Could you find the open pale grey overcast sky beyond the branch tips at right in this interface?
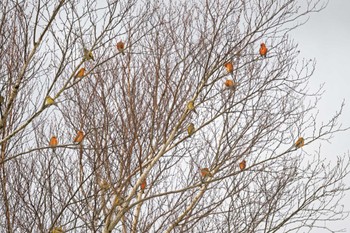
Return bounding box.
[292,0,350,232]
